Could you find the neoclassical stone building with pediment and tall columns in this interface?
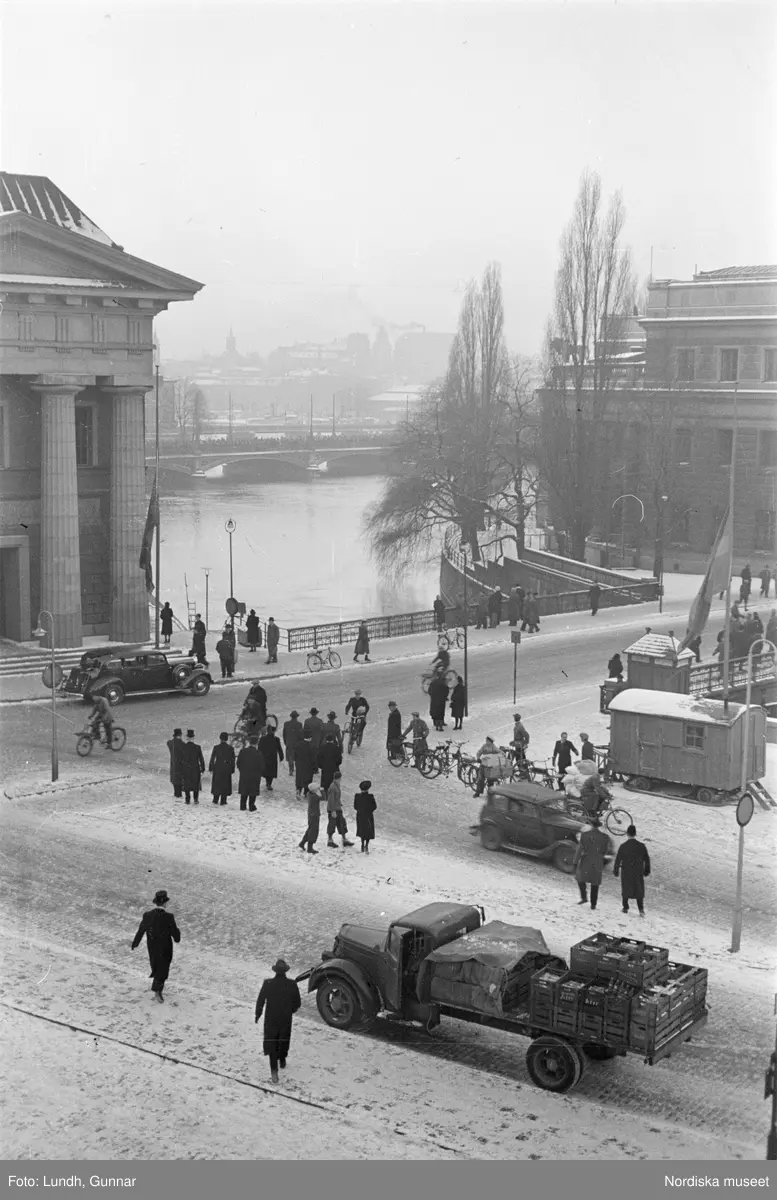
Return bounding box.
[0,173,201,647]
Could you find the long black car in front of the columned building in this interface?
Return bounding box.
[62,646,212,704]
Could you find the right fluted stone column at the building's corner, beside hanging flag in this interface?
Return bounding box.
[101,386,150,642]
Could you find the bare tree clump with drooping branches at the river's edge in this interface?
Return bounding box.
[365,264,536,572]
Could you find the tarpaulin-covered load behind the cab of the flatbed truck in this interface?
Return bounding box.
[416,920,566,1015]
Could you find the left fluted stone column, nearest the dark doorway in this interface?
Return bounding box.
[31,382,84,646]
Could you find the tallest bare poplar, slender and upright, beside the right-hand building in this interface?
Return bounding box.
[538,170,636,559]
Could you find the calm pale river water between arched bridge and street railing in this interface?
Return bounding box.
[159,476,440,629]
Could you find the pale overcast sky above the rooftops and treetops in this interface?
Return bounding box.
[1,0,777,358]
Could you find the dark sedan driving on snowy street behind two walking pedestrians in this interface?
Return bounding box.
[470,782,615,875]
